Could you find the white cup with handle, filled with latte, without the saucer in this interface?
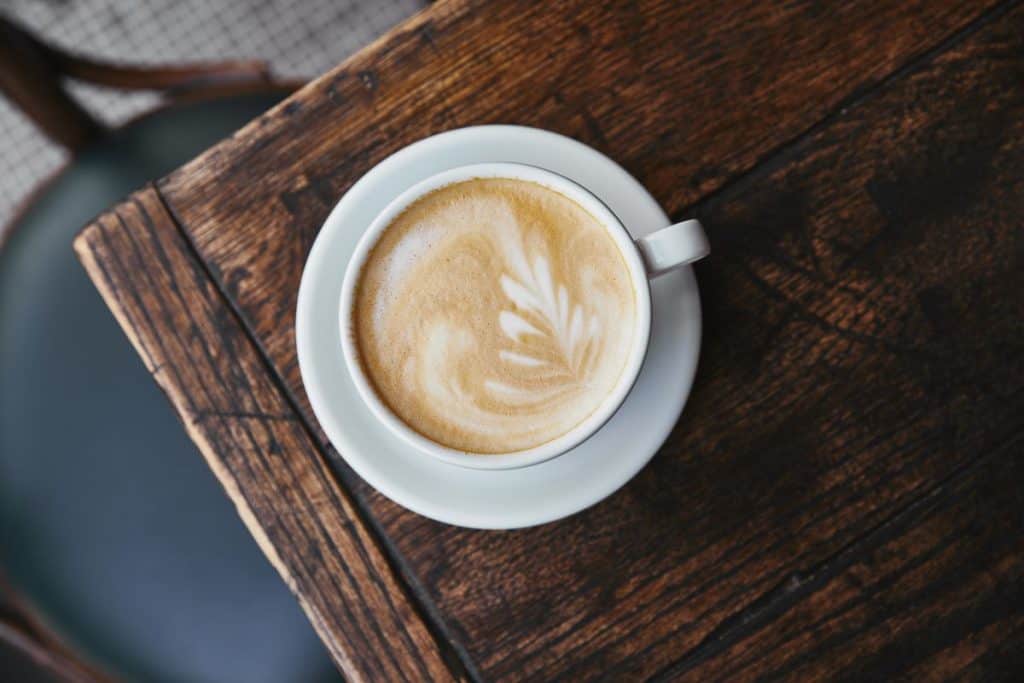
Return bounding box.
[339,163,709,469]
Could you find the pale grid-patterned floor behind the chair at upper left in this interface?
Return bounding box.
[0,0,424,229]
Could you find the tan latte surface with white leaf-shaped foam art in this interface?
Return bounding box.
[350,178,636,454]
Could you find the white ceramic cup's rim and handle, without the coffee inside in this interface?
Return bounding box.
[339,163,710,470]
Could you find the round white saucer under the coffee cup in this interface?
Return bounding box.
[296,126,700,528]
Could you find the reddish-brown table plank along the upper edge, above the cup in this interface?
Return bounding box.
[160,0,995,390]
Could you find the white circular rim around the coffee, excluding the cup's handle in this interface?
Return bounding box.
[338,162,651,470]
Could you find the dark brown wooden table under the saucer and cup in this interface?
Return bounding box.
[75,0,1024,681]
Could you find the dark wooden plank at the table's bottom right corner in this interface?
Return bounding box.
[659,448,1024,683]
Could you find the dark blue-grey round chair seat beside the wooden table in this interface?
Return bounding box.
[0,94,340,683]
